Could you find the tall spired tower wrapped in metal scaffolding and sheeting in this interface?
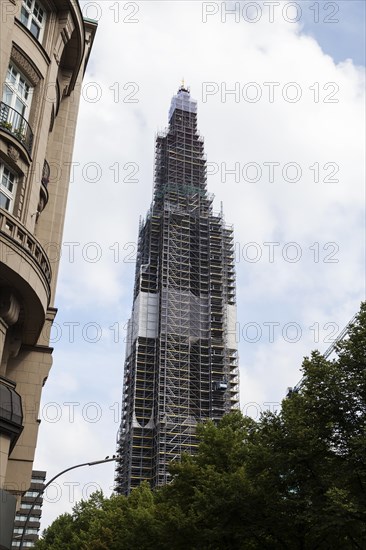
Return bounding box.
[116,88,239,494]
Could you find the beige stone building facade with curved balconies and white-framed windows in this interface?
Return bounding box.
[0,0,96,520]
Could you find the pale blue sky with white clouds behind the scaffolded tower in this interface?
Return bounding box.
[34,0,365,528]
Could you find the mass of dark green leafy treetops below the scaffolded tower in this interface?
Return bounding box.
[36,304,366,550]
